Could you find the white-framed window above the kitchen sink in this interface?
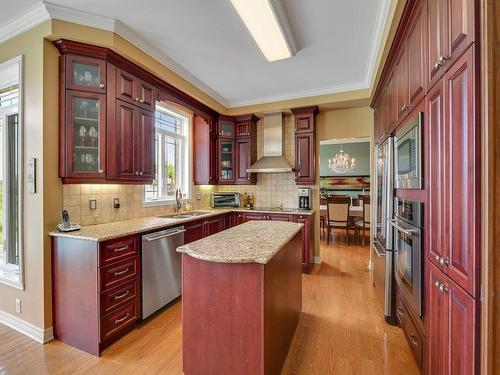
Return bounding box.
[144,104,191,204]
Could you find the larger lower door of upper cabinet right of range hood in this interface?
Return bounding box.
[295,133,316,184]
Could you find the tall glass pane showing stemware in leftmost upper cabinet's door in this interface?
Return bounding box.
[73,98,100,173]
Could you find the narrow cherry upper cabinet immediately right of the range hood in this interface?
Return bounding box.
[291,106,319,185]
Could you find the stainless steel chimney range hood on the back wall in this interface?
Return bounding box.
[247,112,293,173]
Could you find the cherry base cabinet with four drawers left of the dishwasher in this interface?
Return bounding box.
[52,236,141,356]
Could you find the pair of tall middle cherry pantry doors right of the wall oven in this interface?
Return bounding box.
[428,46,481,297]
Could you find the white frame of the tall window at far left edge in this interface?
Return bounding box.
[0,55,25,290]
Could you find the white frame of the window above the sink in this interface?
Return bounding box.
[142,102,193,207]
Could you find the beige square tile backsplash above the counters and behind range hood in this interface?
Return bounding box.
[63,116,317,225]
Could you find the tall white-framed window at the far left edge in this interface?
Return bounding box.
[0,56,23,288]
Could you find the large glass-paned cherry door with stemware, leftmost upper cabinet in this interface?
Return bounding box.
[61,90,106,179]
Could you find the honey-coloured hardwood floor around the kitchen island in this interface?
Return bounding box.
[0,237,418,375]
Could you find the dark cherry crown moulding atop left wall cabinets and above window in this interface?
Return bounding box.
[54,39,219,119]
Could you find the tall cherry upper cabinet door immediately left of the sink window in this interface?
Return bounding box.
[134,109,155,181]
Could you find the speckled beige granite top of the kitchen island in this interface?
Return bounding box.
[177,221,303,264]
